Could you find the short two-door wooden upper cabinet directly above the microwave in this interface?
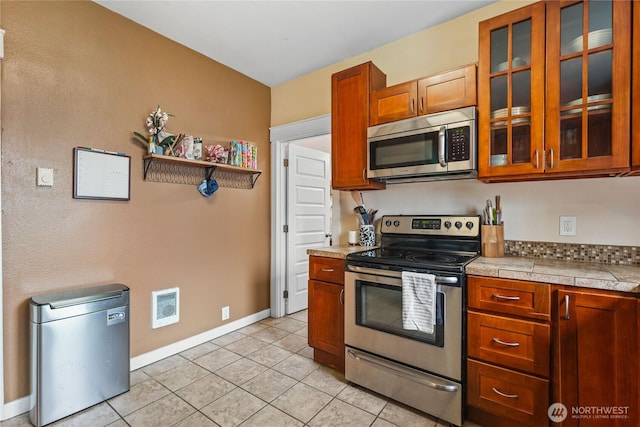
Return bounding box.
[370,64,477,126]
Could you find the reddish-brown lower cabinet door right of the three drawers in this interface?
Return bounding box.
[553,287,640,427]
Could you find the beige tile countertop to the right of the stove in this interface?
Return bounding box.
[466,257,640,296]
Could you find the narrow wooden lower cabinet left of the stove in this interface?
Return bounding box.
[308,256,344,372]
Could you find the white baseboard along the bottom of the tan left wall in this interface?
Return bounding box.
[0,309,271,421]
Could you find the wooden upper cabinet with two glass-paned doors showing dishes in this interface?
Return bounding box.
[478,0,631,181]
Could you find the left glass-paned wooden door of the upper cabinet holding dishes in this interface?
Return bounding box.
[478,2,545,179]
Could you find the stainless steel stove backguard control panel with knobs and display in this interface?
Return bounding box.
[380,215,480,237]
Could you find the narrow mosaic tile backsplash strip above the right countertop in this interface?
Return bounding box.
[504,240,640,265]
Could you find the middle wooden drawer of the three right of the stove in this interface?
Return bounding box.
[467,311,551,377]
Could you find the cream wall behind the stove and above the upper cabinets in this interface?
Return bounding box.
[271,0,640,246]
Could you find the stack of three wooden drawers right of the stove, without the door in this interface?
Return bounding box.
[466,276,551,427]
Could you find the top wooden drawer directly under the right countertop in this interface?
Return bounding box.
[467,276,551,321]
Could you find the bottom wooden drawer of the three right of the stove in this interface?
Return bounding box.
[467,360,549,426]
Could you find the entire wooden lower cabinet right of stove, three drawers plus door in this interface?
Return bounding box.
[466,276,640,427]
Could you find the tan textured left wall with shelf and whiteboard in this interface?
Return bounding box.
[0,1,271,402]
